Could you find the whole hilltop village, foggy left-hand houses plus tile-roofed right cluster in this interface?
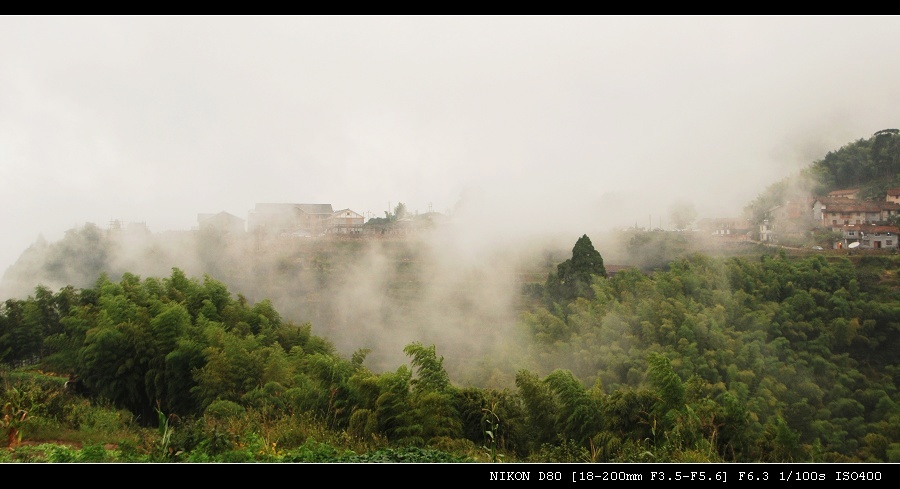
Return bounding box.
[190,187,900,250]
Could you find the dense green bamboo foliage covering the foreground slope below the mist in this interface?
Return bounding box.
[0,242,900,462]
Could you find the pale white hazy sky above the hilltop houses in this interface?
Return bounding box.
[0,16,900,273]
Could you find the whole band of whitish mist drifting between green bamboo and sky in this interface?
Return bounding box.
[0,124,900,385]
